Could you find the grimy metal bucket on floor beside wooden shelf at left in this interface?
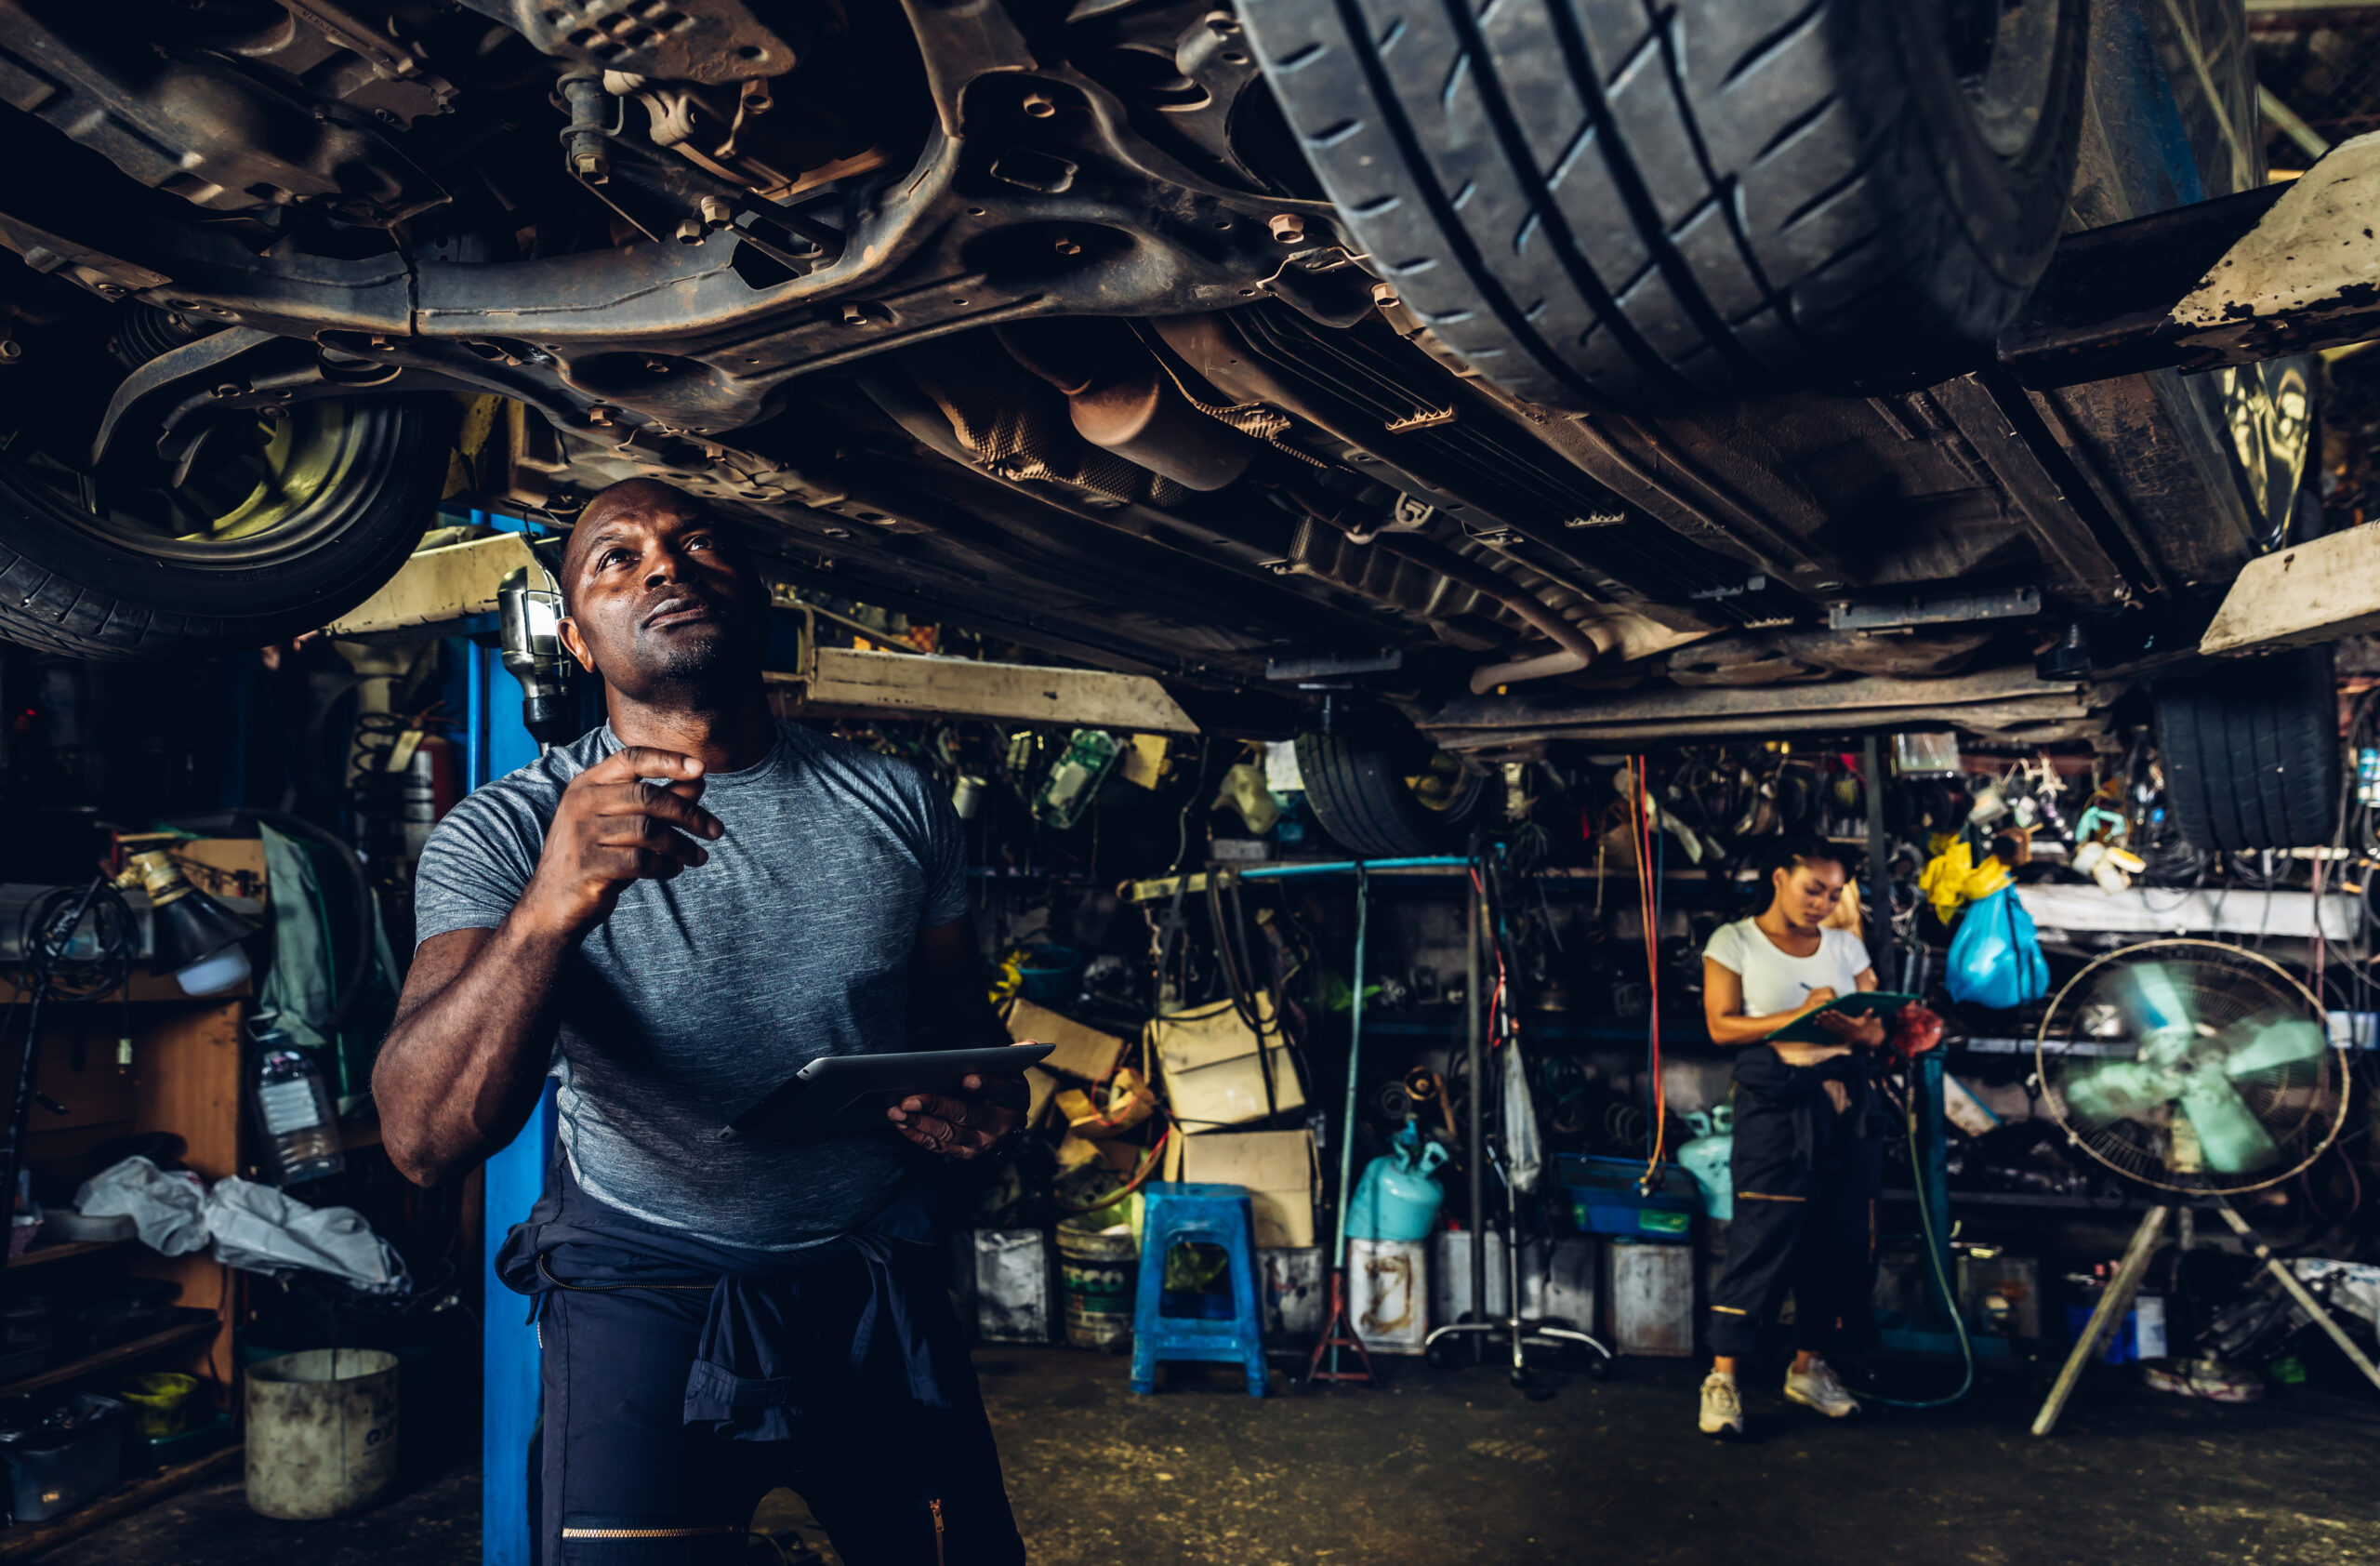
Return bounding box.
[247,1349,398,1519]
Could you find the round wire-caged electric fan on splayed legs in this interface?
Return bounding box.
[2032,940,2380,1435]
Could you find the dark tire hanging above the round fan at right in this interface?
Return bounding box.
[2156,647,2339,852]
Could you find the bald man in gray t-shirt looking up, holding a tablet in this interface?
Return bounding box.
[374,481,1025,1566]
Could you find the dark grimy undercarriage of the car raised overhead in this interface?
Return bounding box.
[0,0,2320,754]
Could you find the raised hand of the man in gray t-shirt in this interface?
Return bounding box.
[517,745,726,936]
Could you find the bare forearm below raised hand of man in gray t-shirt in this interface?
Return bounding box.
[371,909,576,1186]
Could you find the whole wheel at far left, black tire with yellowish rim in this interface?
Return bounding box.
[0,395,452,659]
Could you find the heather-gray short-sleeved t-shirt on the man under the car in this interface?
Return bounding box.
[414,723,966,1250]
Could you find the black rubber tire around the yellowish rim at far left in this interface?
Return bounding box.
[0,395,455,661]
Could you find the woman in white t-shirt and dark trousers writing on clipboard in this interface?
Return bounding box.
[1699,838,1885,1435]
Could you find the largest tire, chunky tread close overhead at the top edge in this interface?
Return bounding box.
[1242,0,2087,412]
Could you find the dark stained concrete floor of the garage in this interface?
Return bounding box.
[43,1347,2380,1566]
